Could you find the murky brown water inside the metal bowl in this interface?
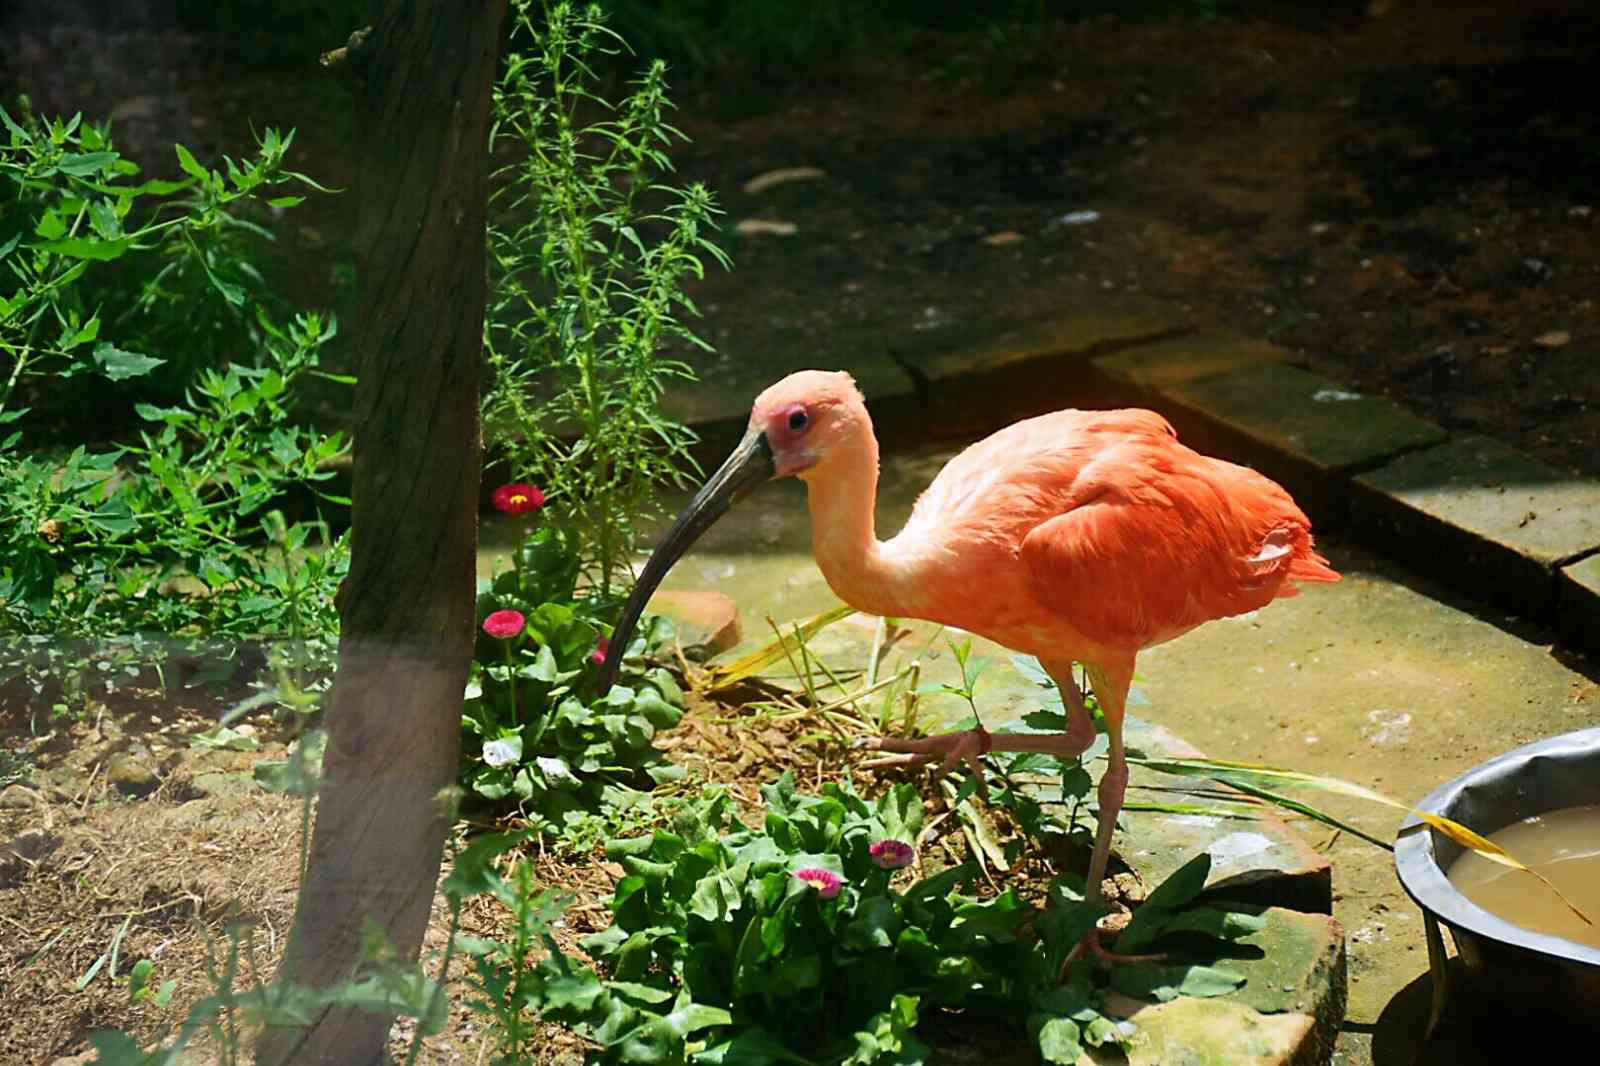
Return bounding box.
[1448,805,1600,948]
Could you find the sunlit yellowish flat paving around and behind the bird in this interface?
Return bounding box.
[485,435,1600,1066]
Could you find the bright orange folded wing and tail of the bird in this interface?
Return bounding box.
[1018,442,1338,648]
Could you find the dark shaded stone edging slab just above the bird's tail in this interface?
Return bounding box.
[1157,362,1446,527]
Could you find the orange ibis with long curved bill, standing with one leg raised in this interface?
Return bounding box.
[602,370,1339,900]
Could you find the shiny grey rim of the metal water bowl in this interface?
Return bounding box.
[1394,727,1600,968]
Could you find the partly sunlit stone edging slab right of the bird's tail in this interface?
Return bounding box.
[1350,437,1600,618]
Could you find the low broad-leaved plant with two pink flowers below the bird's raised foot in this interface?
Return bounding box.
[467,775,1262,1066]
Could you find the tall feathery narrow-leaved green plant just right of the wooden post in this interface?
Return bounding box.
[483,0,728,595]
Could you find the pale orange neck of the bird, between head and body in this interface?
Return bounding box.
[802,429,894,615]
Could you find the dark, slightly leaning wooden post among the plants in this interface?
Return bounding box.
[258,0,506,1066]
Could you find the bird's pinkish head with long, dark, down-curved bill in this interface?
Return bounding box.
[600,370,869,691]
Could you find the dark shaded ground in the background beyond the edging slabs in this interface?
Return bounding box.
[0,0,1600,474]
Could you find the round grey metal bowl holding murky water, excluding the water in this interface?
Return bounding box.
[1395,728,1600,1021]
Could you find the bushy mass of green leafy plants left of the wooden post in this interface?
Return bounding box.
[0,106,349,709]
